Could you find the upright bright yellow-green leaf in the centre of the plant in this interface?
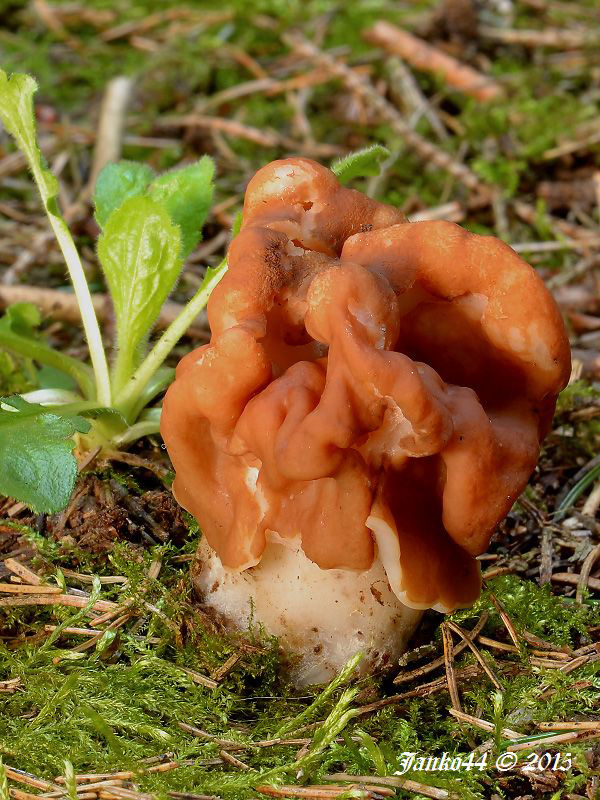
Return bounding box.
[98,197,183,390]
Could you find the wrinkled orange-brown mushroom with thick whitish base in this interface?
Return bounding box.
[161,158,570,685]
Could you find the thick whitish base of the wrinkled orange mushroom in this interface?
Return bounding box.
[192,538,423,686]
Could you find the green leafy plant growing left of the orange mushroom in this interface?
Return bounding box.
[0,71,227,512]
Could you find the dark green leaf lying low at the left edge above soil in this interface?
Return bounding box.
[0,395,90,513]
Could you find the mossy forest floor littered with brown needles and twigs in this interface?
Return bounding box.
[0,0,600,800]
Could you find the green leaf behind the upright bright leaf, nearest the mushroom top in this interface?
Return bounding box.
[148,156,215,258]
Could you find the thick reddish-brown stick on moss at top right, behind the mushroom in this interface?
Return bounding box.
[364,20,504,103]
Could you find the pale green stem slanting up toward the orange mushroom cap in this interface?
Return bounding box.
[114,259,227,418]
